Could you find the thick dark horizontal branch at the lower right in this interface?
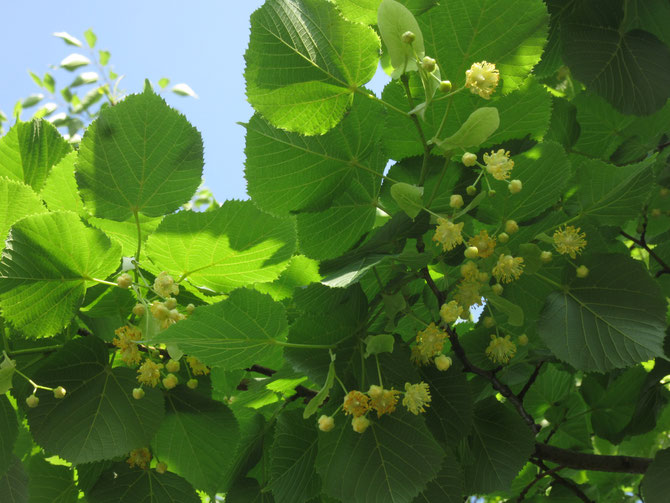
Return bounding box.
[533,442,652,473]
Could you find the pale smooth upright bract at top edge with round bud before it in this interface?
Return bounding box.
[377,0,426,78]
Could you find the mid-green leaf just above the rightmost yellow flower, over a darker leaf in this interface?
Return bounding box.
[576,156,655,225]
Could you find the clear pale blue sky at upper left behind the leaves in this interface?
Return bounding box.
[0,0,388,201]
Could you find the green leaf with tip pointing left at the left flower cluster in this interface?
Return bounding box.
[158,289,288,370]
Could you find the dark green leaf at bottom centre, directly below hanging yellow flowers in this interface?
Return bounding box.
[316,408,444,503]
